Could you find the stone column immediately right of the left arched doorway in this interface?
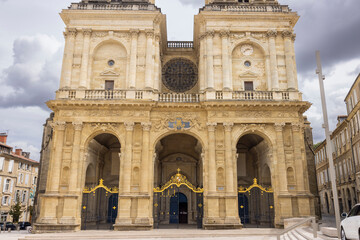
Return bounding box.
[122,122,135,193]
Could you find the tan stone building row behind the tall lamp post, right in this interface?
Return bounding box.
[315,75,360,215]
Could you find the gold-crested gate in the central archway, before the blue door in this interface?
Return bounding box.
[153,169,204,228]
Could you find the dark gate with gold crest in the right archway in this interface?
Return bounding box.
[238,178,274,228]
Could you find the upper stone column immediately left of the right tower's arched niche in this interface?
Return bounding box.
[220,31,233,91]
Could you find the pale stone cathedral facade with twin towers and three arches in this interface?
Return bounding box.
[35,0,315,232]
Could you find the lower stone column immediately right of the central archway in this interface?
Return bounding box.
[207,123,217,193]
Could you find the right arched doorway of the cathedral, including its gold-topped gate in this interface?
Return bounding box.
[236,134,275,227]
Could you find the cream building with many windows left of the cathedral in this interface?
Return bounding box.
[0,133,39,222]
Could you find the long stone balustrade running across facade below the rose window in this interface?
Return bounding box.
[56,89,302,103]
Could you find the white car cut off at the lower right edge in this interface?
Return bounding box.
[341,203,360,240]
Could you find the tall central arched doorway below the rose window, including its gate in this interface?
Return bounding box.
[154,133,203,228]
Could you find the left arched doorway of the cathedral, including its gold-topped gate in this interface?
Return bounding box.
[81,133,121,230]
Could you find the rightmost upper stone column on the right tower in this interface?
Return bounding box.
[282,31,296,90]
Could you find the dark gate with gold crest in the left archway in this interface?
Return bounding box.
[81,179,119,230]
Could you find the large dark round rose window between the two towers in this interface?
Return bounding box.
[162,58,198,92]
